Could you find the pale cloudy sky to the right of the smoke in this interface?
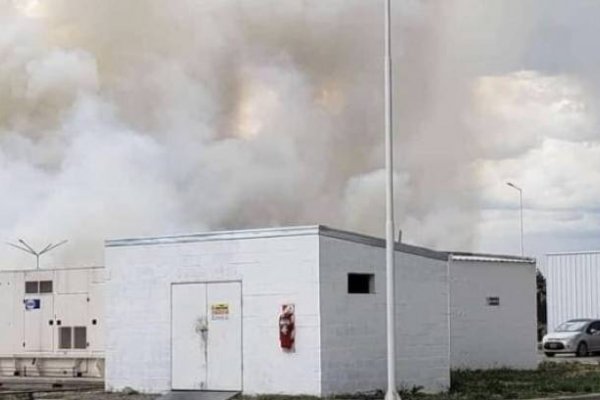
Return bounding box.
[468,0,600,255]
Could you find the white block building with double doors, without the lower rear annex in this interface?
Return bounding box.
[106,226,450,396]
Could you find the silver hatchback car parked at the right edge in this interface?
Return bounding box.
[542,319,600,357]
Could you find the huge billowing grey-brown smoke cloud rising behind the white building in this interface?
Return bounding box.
[0,0,596,266]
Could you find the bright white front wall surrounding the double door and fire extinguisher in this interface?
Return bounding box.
[106,234,321,395]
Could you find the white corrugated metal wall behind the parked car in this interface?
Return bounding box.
[544,251,600,332]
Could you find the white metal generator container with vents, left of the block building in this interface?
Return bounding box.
[0,268,105,377]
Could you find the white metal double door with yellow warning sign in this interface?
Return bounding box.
[171,282,242,391]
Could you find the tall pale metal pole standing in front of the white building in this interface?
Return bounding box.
[384,0,400,400]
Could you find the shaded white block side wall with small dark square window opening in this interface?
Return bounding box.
[320,237,450,394]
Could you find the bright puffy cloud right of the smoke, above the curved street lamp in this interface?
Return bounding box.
[471,71,598,158]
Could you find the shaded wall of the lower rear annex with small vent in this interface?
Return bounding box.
[450,260,537,369]
